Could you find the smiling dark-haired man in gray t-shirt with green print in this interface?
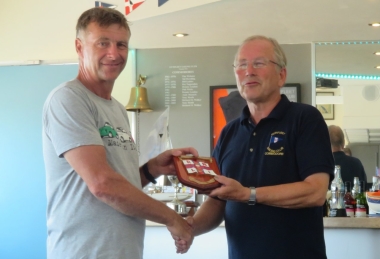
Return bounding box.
[43,8,198,259]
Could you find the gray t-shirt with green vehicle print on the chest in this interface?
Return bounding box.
[42,80,145,259]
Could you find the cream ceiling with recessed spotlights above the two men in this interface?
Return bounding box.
[127,0,380,49]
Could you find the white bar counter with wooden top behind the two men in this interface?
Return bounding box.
[144,217,380,259]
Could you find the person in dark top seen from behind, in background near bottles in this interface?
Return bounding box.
[329,125,367,186]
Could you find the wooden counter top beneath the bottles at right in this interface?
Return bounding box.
[323,217,380,229]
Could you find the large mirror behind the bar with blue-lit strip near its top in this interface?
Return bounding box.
[313,41,380,182]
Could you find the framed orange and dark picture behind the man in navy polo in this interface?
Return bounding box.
[210,83,301,154]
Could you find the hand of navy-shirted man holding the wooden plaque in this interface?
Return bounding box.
[209,175,251,202]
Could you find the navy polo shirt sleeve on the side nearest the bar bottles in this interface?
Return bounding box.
[296,106,334,180]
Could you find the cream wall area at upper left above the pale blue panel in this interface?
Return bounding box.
[0,0,125,62]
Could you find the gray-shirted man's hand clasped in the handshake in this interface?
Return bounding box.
[166,215,194,254]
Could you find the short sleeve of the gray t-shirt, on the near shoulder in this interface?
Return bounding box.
[44,87,103,157]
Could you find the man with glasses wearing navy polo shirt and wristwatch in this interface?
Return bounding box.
[183,36,334,259]
